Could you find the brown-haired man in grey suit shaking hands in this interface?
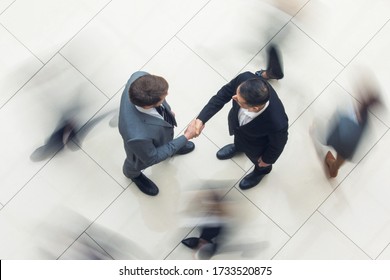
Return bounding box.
[118,71,197,196]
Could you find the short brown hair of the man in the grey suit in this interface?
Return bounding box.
[129,75,168,107]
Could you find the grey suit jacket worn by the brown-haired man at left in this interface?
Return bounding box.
[118,71,187,178]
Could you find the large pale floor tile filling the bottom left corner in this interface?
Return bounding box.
[0,143,123,259]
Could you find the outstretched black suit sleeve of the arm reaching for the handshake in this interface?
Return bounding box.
[197,72,253,123]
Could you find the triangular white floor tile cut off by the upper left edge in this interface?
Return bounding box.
[0,24,43,108]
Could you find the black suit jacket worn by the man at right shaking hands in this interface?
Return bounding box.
[198,72,288,164]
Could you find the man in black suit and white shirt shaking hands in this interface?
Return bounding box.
[196,47,288,190]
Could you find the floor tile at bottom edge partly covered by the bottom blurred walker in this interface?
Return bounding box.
[167,188,289,260]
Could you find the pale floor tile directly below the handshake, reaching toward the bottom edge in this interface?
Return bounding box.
[87,136,243,259]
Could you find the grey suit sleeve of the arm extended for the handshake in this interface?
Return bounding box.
[127,135,187,166]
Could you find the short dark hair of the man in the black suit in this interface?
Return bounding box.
[239,78,269,106]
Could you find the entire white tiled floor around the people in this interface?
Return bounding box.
[0,0,390,260]
